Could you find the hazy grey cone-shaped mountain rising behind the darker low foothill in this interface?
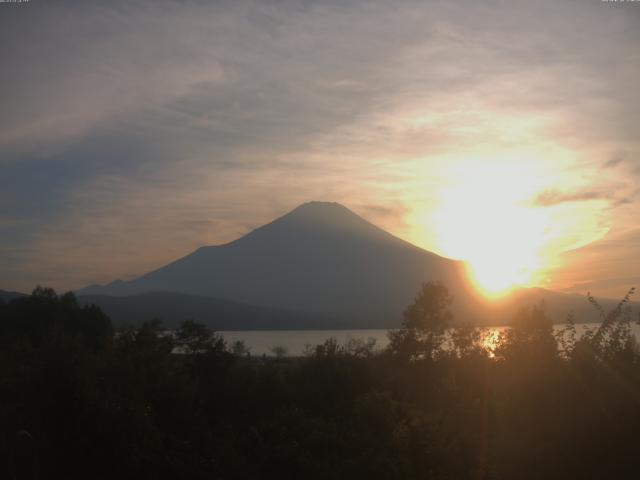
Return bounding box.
[79,202,465,327]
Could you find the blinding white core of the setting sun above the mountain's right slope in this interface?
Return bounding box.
[424,159,552,297]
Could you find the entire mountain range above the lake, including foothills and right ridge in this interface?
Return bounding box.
[78,202,632,328]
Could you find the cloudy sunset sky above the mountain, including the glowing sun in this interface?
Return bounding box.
[0,0,640,297]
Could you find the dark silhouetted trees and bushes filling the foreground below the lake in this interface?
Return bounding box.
[0,284,640,479]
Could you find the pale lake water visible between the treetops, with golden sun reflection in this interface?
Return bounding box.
[218,323,640,356]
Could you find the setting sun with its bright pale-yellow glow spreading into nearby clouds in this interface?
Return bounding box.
[408,152,610,299]
